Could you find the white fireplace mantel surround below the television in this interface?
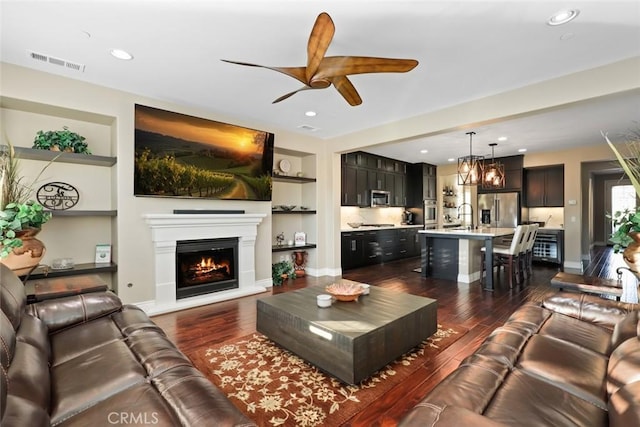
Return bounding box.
[141,214,267,314]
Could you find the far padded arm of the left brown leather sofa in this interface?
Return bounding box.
[27,291,122,333]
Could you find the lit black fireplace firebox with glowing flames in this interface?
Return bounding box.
[176,238,238,299]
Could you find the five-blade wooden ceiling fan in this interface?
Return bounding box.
[222,12,418,106]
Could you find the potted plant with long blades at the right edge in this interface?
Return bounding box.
[603,129,640,277]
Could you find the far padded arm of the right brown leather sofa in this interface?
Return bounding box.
[542,292,640,329]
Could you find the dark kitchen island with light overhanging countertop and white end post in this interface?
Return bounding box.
[418,228,515,291]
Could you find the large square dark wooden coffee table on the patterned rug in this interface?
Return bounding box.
[256,280,438,384]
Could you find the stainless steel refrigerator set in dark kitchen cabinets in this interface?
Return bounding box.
[478,193,520,228]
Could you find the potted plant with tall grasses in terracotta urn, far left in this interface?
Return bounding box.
[0,143,51,275]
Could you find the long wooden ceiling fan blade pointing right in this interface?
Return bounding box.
[313,56,418,79]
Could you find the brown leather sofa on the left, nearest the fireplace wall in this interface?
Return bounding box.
[0,264,255,427]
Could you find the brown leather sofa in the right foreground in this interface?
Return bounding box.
[399,293,640,427]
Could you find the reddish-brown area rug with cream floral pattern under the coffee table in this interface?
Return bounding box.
[192,325,467,427]
